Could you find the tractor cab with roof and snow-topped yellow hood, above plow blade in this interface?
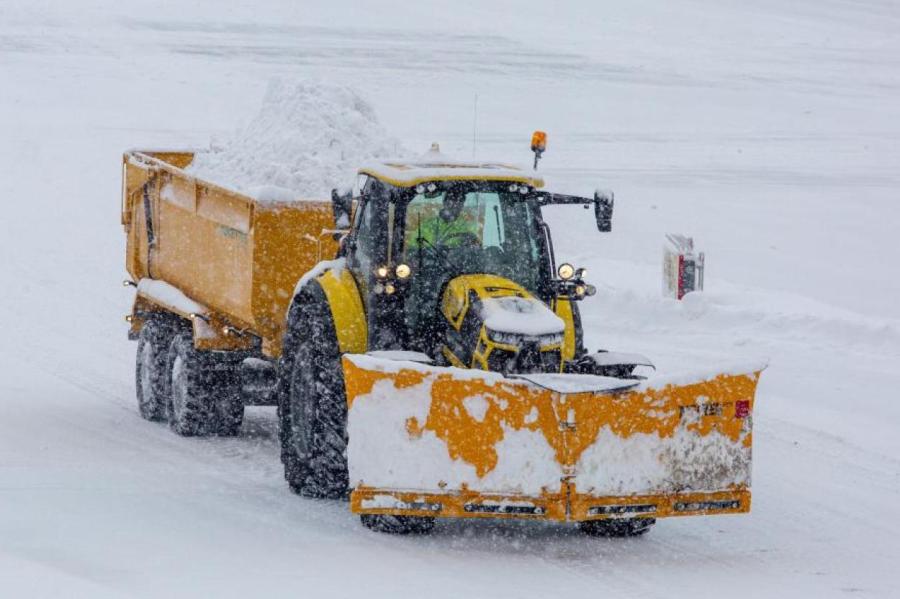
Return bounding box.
[334,150,616,372]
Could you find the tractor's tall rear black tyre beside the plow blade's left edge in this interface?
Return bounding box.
[280,287,349,499]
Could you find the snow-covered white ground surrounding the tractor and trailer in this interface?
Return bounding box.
[0,0,900,597]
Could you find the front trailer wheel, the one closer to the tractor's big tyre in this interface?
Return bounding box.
[167,331,244,437]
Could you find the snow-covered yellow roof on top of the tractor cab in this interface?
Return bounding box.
[359,144,544,188]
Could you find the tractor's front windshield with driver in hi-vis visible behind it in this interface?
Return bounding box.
[402,183,546,342]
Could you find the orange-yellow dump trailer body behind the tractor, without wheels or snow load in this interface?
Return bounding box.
[122,151,337,357]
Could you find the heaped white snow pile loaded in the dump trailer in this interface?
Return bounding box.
[186,80,401,202]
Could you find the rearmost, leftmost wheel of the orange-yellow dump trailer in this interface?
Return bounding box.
[134,320,172,420]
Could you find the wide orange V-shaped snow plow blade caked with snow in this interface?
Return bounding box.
[343,354,764,521]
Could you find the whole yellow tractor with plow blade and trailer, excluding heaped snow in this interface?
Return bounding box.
[123,143,762,536]
